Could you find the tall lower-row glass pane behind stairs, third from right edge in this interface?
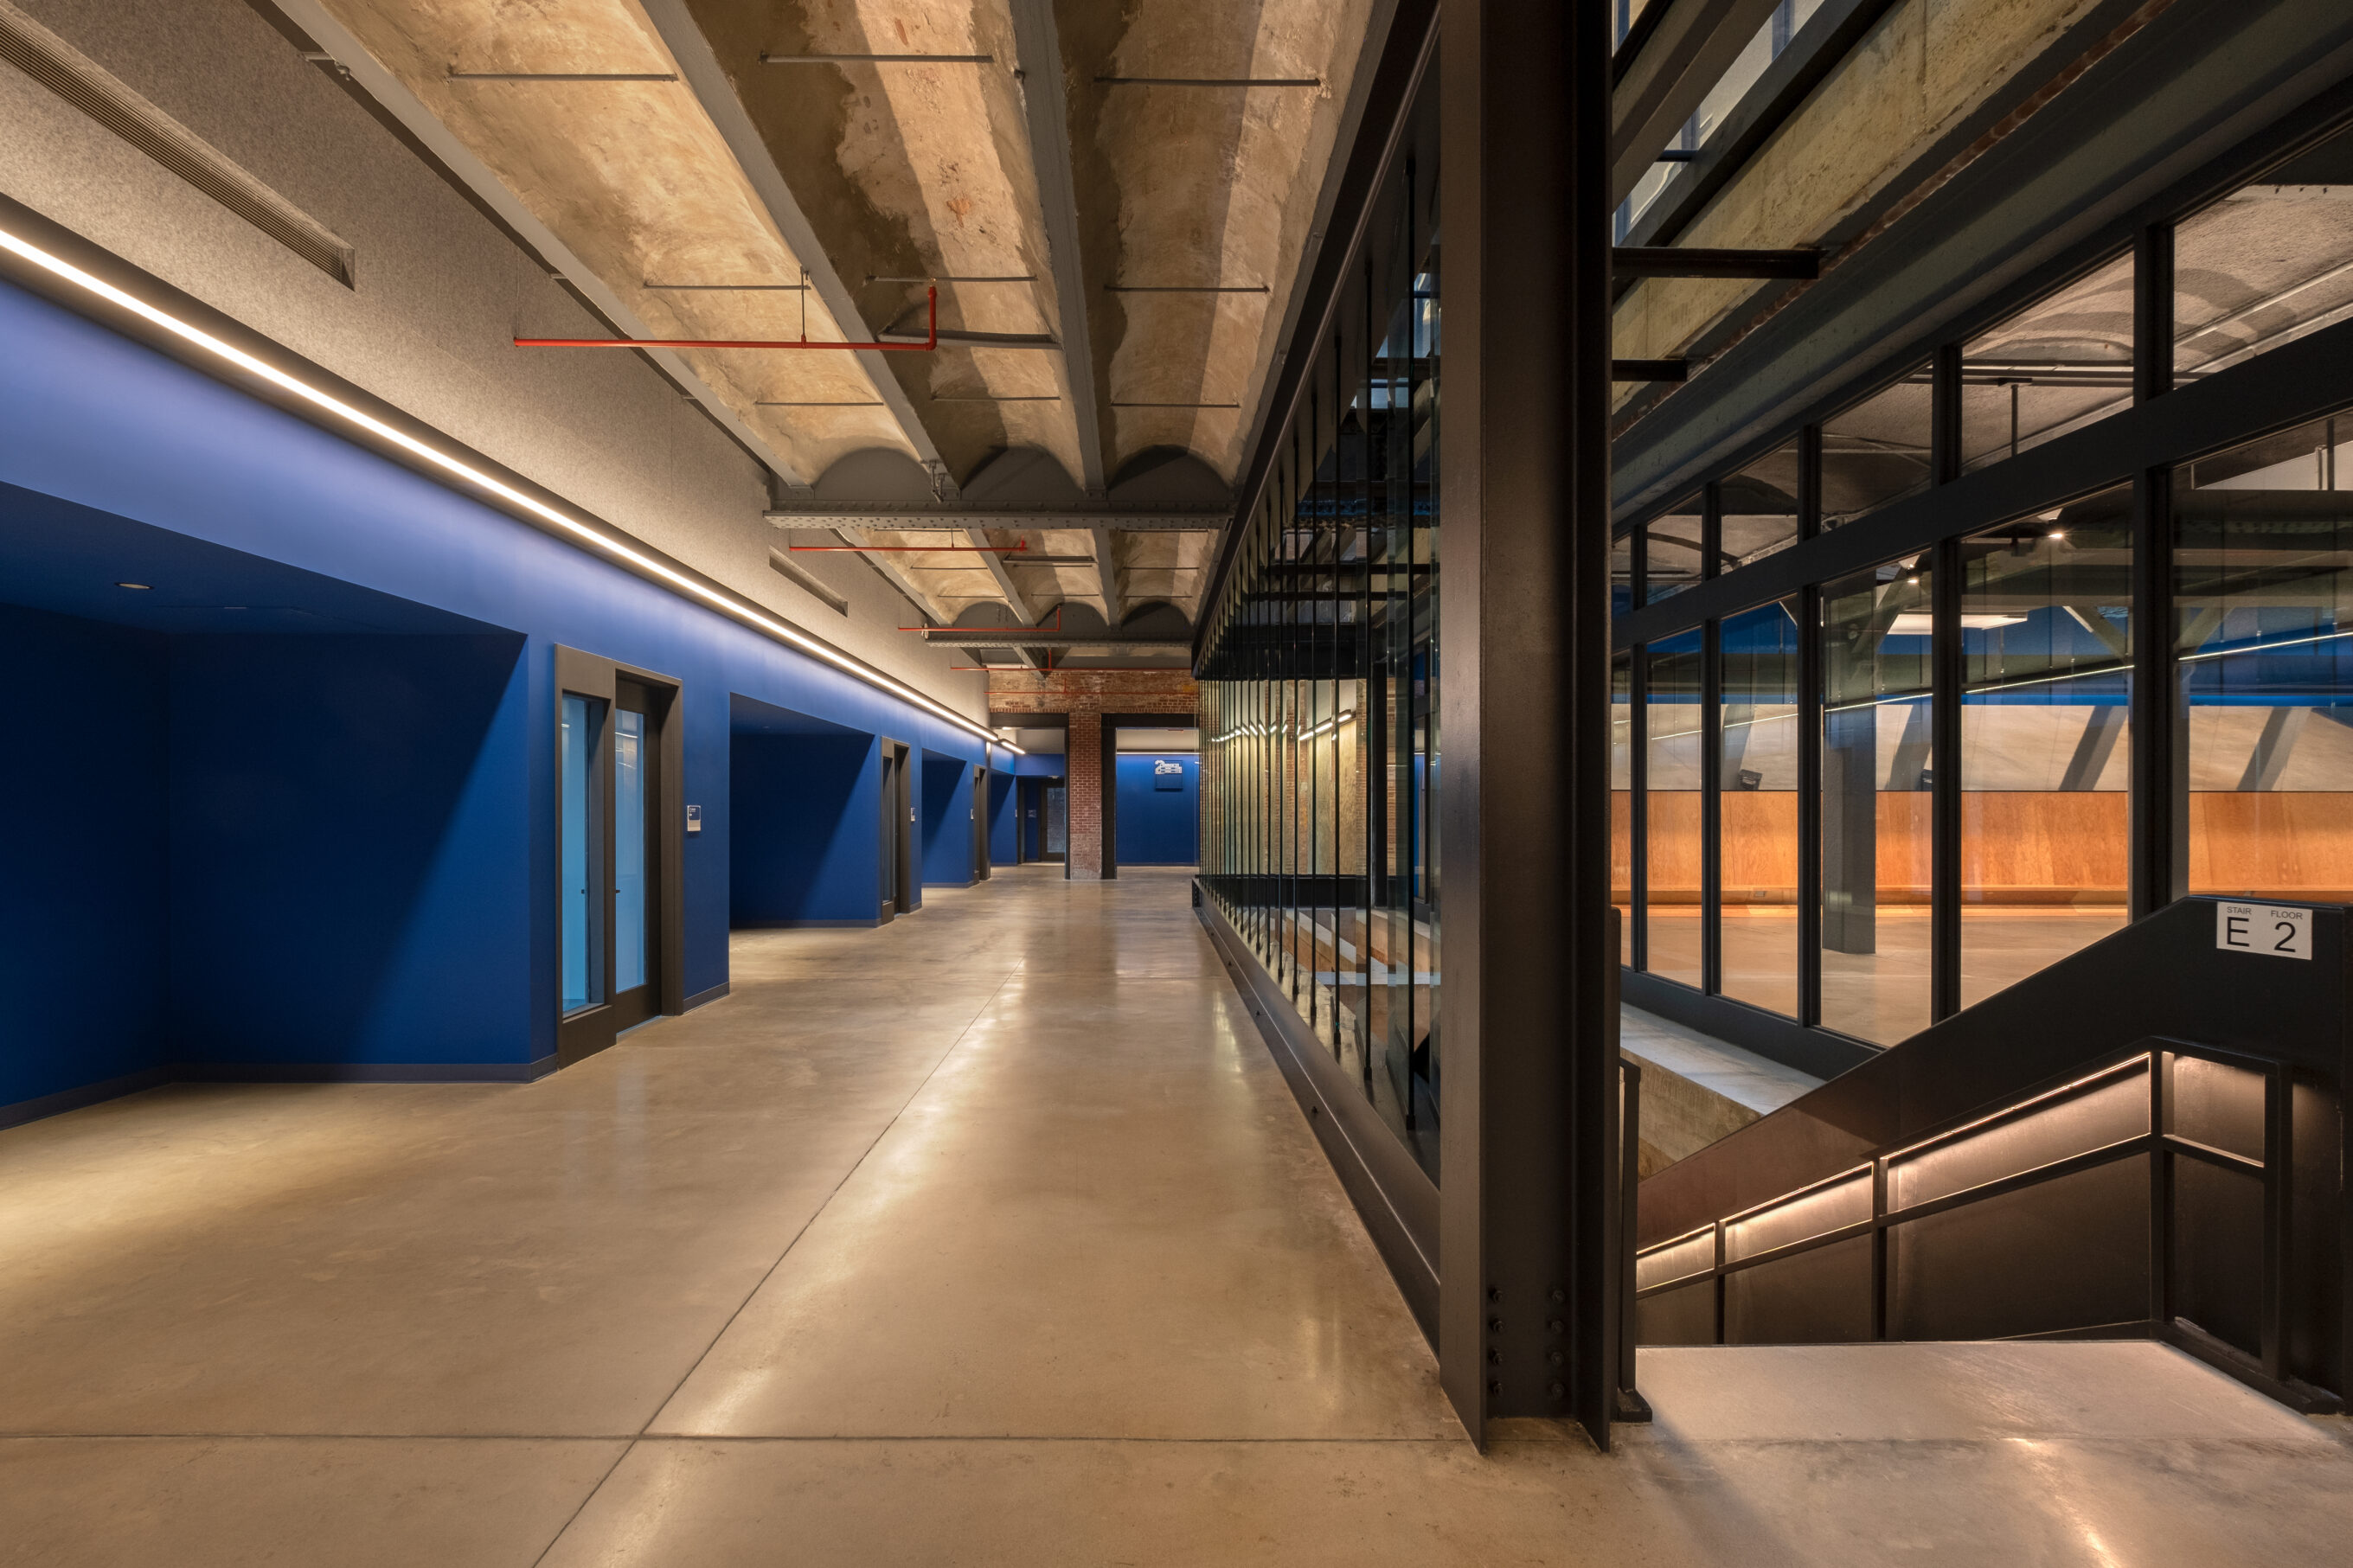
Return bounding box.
[1821,560,1937,1046]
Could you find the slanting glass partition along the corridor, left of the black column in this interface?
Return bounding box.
[1197,73,1445,1178]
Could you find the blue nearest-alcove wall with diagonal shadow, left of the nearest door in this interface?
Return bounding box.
[170,637,534,1065]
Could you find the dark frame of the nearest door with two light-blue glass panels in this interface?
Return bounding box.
[548,644,687,1067]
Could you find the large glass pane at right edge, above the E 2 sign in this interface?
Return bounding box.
[2174,419,2353,903]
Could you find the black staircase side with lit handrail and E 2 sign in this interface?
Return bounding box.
[1635,898,2353,1413]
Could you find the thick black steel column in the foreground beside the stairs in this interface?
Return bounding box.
[1438,0,1617,1441]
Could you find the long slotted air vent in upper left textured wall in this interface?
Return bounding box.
[0,0,353,289]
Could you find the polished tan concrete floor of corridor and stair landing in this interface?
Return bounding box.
[0,870,2353,1568]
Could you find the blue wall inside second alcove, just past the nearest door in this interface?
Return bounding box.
[727,733,882,926]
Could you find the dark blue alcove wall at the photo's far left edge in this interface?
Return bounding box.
[0,606,170,1105]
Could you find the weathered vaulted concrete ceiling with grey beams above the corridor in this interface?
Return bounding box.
[280,0,1379,643]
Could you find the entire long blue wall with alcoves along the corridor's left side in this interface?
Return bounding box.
[0,272,1011,1103]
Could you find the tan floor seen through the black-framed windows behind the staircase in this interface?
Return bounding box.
[1650,905,2125,1046]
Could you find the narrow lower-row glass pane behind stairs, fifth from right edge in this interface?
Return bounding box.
[1643,632,1703,985]
